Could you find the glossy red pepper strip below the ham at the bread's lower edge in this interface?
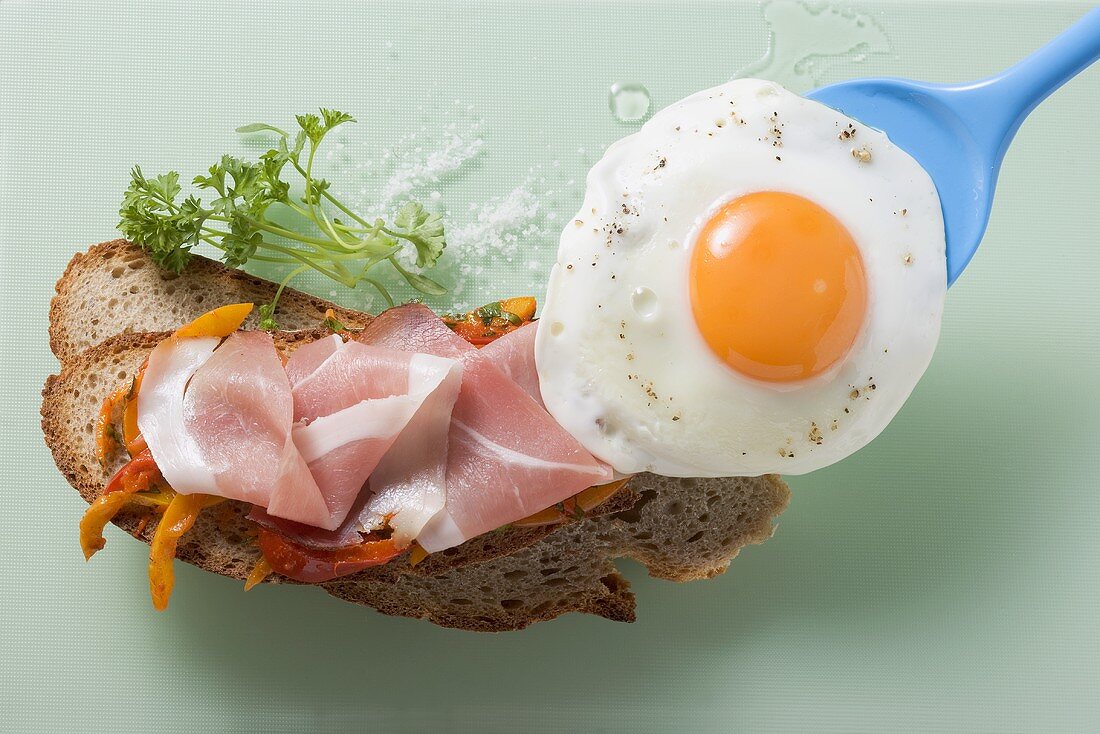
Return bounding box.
[260,528,403,583]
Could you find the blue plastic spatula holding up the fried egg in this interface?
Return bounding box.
[806,8,1100,285]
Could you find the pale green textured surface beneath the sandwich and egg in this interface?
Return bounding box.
[0,0,1100,732]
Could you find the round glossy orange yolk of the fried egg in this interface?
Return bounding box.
[690,191,867,382]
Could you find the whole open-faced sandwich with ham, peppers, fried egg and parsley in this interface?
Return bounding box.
[42,80,946,629]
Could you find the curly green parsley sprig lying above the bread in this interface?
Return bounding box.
[119,109,447,329]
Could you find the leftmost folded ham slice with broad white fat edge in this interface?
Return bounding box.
[138,331,317,522]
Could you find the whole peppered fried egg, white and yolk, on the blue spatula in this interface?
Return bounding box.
[536,79,947,476]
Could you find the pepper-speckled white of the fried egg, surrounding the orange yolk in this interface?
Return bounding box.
[536,79,947,476]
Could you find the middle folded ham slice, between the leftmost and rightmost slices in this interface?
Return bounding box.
[275,336,462,534]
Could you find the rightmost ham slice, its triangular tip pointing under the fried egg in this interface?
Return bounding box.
[356,304,611,552]
